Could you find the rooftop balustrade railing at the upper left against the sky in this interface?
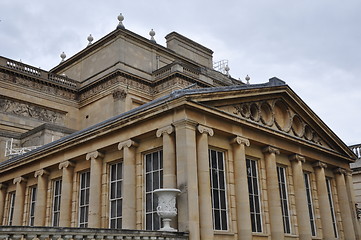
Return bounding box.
[0,57,78,88]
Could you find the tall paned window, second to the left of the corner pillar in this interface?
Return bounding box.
[109,162,123,229]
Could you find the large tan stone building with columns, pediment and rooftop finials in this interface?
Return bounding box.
[0,16,360,240]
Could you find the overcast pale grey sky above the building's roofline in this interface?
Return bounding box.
[0,0,361,145]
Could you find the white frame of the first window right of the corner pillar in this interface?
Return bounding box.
[208,148,229,231]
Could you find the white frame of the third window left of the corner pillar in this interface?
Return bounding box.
[78,170,91,228]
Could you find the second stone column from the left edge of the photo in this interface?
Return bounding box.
[12,177,27,226]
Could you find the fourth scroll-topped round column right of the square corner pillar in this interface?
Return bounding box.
[289,154,312,240]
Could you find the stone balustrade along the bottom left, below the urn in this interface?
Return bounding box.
[0,226,188,240]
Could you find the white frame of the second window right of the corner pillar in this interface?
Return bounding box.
[245,157,263,233]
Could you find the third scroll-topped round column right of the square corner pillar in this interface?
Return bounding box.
[262,146,284,240]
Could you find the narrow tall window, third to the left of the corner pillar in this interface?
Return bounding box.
[79,172,90,228]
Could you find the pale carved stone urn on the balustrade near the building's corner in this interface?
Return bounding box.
[154,188,181,232]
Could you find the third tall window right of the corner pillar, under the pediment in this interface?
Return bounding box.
[277,166,291,233]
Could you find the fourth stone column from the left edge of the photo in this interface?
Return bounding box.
[59,161,75,227]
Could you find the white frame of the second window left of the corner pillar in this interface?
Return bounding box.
[109,161,124,229]
